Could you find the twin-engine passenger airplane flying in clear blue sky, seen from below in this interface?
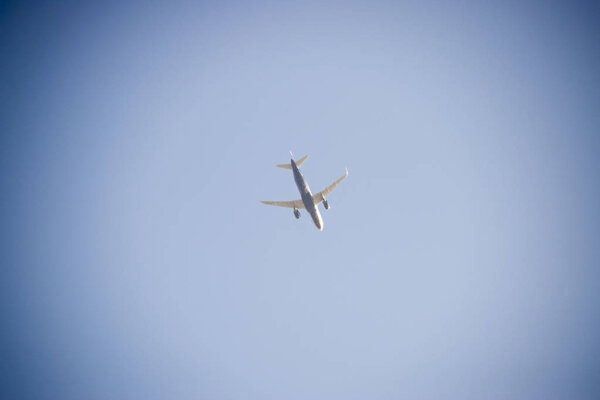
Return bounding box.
[261,151,348,231]
